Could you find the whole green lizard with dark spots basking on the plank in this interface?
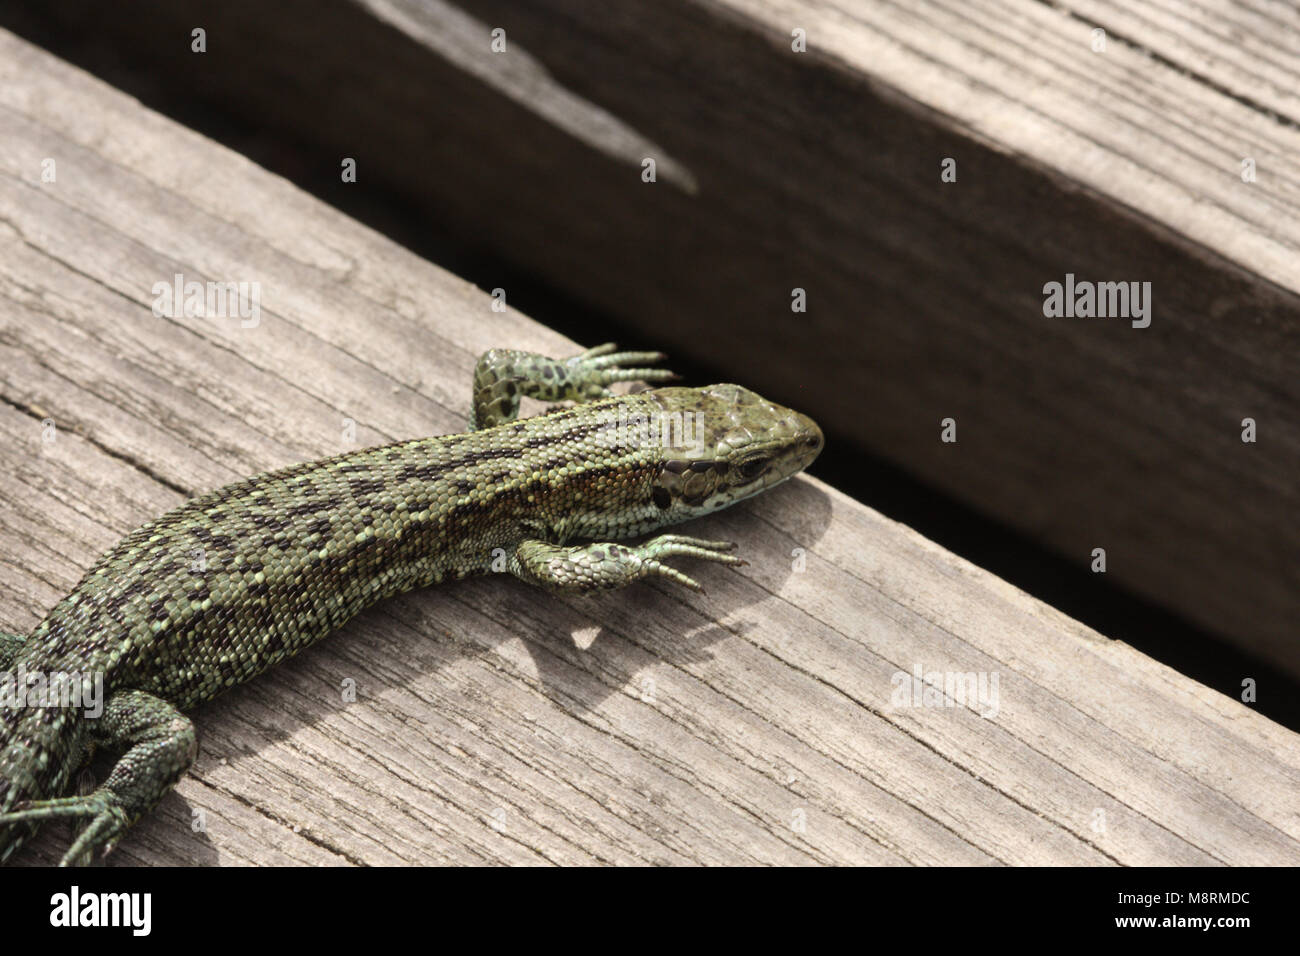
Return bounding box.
[0,345,822,865]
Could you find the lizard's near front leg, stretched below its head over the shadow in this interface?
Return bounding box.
[508,535,748,592]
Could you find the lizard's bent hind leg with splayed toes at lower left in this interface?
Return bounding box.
[0,691,198,866]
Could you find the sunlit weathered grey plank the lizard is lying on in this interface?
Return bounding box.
[0,33,1300,864]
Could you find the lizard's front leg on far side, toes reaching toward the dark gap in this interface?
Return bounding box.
[469,342,677,431]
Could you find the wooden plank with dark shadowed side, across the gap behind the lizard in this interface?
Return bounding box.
[9,0,1300,675]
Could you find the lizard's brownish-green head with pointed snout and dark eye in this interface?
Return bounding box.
[646,385,823,520]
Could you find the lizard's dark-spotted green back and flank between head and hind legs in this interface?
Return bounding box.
[16,399,657,709]
